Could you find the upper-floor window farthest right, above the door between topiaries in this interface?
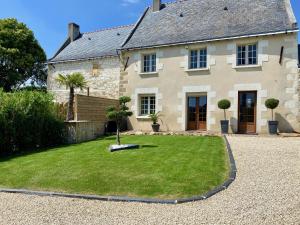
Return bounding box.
[237,44,257,66]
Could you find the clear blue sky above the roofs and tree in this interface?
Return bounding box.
[0,0,300,58]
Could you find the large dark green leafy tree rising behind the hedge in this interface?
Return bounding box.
[0,19,47,91]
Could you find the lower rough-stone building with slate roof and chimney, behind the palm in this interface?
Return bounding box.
[47,23,132,102]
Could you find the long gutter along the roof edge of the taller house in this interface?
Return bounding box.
[120,28,299,51]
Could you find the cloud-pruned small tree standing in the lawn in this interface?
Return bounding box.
[107,96,132,145]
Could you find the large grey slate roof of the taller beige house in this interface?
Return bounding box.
[122,0,296,49]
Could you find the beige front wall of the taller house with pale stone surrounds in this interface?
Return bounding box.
[120,33,300,133]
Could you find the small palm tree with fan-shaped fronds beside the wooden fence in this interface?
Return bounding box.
[56,73,87,121]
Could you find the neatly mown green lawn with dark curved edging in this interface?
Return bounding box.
[0,136,229,199]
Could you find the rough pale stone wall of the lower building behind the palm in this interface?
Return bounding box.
[47,57,120,102]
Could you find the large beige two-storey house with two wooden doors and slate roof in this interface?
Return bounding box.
[49,0,300,133]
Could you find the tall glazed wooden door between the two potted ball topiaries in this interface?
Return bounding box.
[239,91,257,134]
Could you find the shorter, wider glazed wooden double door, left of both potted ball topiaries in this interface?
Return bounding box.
[187,96,207,130]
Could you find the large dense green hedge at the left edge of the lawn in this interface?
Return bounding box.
[0,90,64,155]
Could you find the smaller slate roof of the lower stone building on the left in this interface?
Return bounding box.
[49,25,133,63]
